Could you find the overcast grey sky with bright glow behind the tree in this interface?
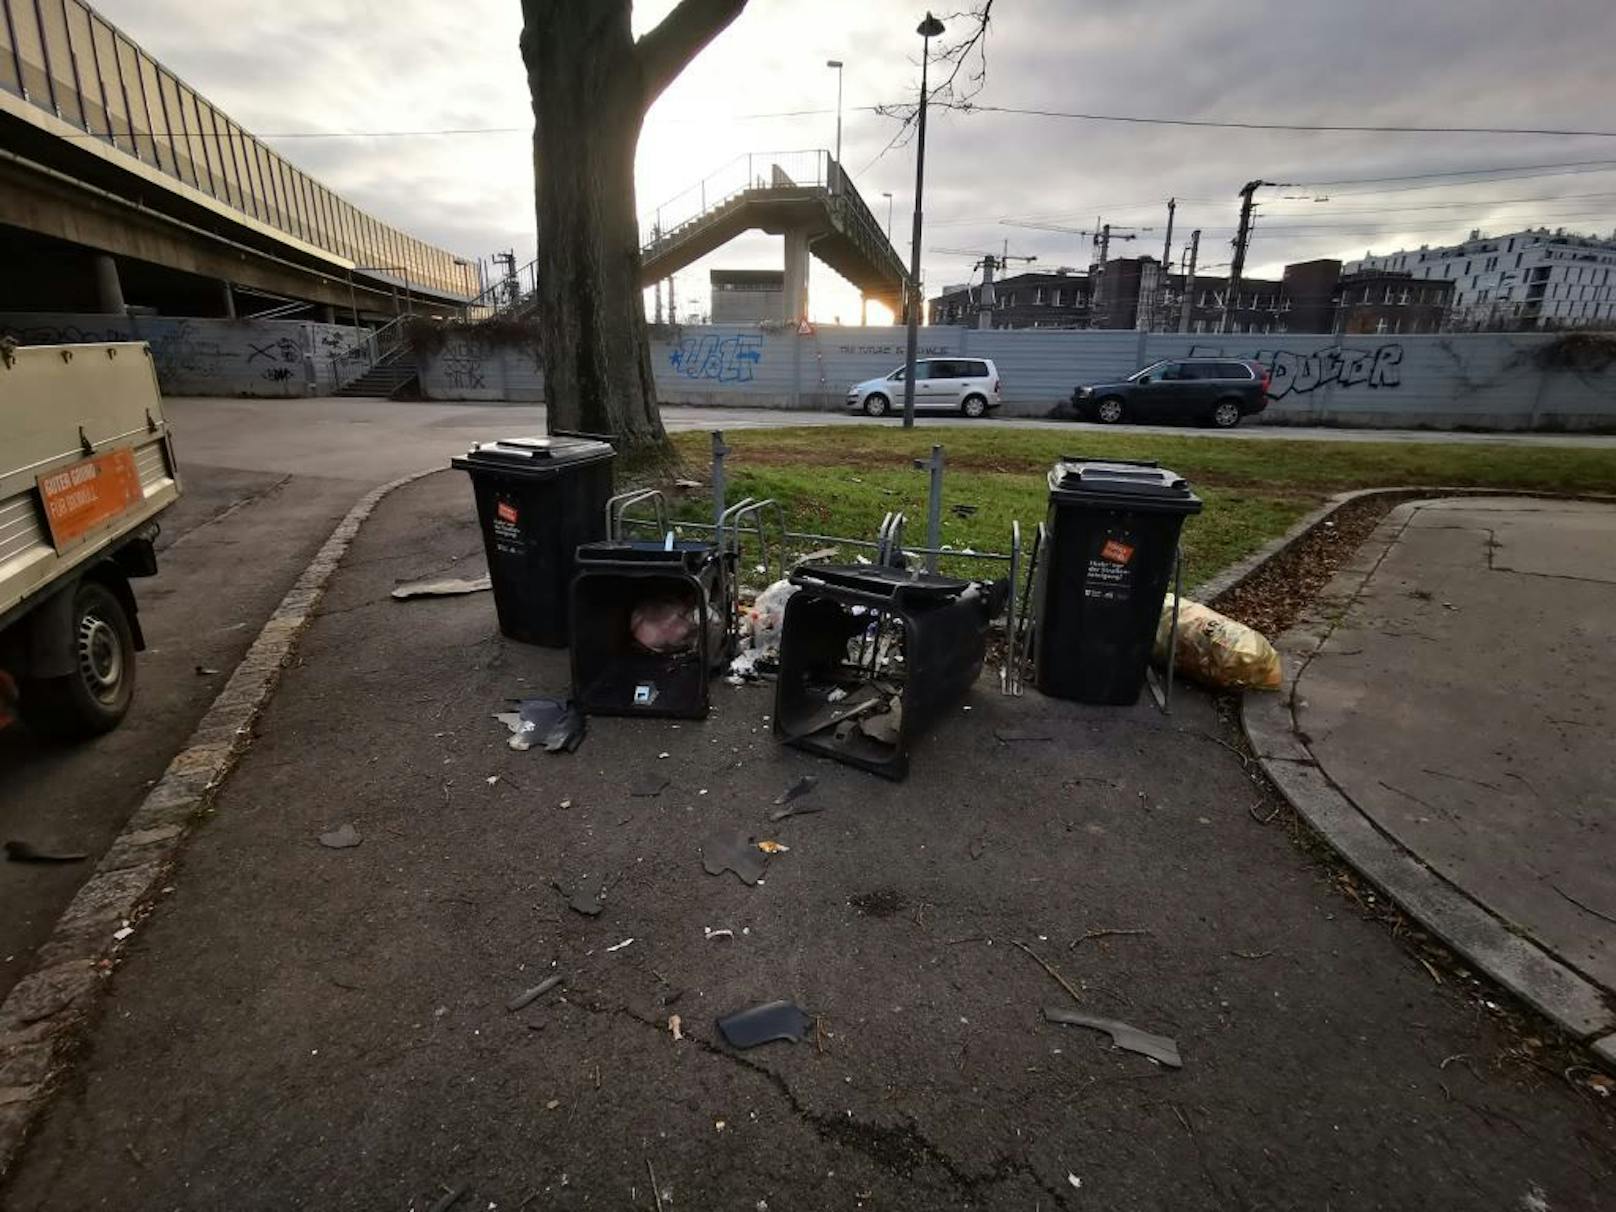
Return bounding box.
[97,0,1616,322]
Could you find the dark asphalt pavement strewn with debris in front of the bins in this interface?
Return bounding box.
[0,473,1616,1212]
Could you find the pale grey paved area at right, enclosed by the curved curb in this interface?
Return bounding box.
[1248,498,1616,1062]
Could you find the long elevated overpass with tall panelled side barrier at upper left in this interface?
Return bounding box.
[0,0,478,320]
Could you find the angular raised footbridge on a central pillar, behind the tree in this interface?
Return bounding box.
[640,152,908,325]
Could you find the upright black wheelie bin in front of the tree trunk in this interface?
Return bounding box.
[452,438,614,648]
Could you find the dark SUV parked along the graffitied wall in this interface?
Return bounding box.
[1071,357,1269,430]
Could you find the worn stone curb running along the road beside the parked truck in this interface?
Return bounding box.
[0,467,443,1175]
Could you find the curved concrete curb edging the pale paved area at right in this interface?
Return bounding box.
[1241,490,1616,1068]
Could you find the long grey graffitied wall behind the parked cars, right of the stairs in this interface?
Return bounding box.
[422,325,1616,430]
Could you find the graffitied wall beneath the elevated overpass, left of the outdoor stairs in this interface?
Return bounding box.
[0,314,364,396]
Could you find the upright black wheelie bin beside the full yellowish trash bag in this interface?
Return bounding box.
[1034,456,1201,706]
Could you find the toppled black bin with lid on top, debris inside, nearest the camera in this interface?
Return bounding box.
[774,564,1008,779]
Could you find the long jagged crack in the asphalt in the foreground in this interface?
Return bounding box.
[567,999,1067,1202]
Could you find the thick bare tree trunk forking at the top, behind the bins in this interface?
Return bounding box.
[522,0,745,449]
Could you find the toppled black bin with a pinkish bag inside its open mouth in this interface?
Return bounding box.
[572,540,735,719]
